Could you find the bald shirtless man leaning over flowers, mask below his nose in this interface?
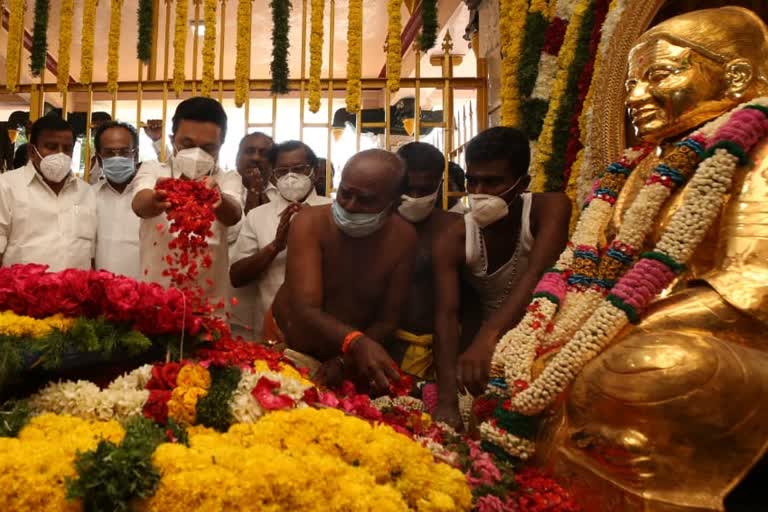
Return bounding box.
[264,149,417,390]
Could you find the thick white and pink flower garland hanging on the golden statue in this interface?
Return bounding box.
[480,98,768,458]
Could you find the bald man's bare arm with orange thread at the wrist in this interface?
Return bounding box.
[285,209,399,389]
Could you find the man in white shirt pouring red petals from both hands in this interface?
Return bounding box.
[132,97,243,305]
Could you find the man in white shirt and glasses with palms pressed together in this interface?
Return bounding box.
[229,141,331,339]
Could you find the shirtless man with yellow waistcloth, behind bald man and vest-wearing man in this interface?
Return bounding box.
[388,142,461,379]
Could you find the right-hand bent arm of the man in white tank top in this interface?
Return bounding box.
[459,193,571,394]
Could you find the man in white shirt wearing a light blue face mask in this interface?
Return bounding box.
[93,121,141,279]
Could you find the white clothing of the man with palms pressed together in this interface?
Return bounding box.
[232,188,332,337]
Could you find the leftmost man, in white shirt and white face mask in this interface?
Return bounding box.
[0,116,96,271]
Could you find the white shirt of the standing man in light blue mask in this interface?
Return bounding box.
[94,180,141,279]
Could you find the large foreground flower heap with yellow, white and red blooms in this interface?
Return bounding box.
[0,339,578,512]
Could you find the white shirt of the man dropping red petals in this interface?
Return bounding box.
[133,161,243,304]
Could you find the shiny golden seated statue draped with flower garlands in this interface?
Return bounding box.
[538,7,768,512]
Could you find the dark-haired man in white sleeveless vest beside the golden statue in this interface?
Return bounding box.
[434,127,571,425]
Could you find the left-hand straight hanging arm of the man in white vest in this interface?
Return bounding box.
[432,222,465,426]
